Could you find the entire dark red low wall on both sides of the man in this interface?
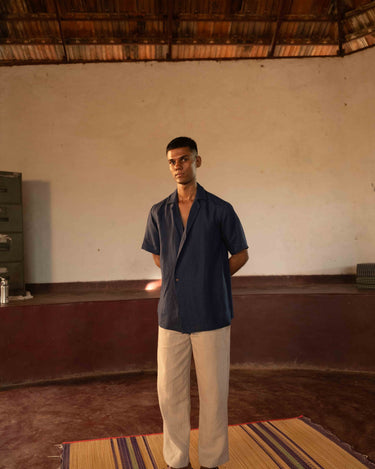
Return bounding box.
[0,278,375,385]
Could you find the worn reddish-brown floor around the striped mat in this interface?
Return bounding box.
[0,369,375,469]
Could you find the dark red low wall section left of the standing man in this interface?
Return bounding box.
[0,299,158,383]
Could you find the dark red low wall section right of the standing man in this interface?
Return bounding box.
[232,293,375,371]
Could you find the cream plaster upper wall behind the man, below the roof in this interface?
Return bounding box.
[0,49,375,283]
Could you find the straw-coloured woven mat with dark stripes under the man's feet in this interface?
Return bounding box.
[61,417,375,469]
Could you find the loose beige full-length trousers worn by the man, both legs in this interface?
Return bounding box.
[158,326,230,468]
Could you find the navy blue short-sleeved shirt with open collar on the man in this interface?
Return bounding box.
[142,184,248,334]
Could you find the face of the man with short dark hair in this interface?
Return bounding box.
[167,147,201,185]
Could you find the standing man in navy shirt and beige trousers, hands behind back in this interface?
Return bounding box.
[142,137,248,469]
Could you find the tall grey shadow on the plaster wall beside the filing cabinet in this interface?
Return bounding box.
[22,181,52,283]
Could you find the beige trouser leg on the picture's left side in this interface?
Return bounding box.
[157,327,192,468]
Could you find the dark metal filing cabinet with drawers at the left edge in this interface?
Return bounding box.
[0,171,25,295]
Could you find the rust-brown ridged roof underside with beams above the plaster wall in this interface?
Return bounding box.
[0,0,375,65]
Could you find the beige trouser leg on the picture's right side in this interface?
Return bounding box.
[191,326,230,467]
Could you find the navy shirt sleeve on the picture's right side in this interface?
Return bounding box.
[221,204,248,255]
